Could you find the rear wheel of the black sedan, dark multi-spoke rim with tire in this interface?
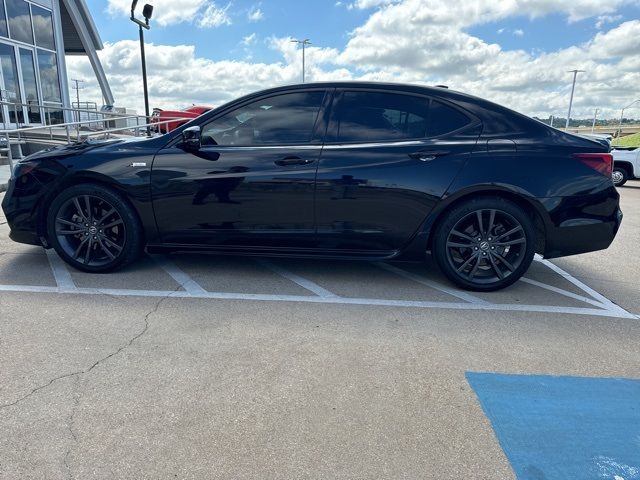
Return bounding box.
[432,197,535,292]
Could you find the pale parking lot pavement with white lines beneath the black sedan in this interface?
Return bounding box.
[0,182,640,480]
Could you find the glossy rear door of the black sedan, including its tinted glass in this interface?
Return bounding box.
[316,89,481,254]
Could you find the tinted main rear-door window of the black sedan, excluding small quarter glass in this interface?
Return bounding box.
[338,92,429,142]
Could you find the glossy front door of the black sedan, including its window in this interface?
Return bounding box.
[151,89,327,248]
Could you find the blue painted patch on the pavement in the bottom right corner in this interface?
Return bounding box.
[466,372,640,480]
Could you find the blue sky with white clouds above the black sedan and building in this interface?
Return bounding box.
[67,0,640,118]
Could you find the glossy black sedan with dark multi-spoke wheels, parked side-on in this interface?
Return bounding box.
[2,83,622,290]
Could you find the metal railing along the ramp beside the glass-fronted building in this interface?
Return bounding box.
[0,100,193,172]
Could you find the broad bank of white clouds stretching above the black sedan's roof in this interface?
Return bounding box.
[82,0,640,118]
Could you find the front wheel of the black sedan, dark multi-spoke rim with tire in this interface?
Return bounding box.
[47,184,143,273]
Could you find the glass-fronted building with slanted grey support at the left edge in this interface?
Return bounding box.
[0,0,113,128]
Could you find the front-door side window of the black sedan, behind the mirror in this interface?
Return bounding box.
[202,91,325,146]
